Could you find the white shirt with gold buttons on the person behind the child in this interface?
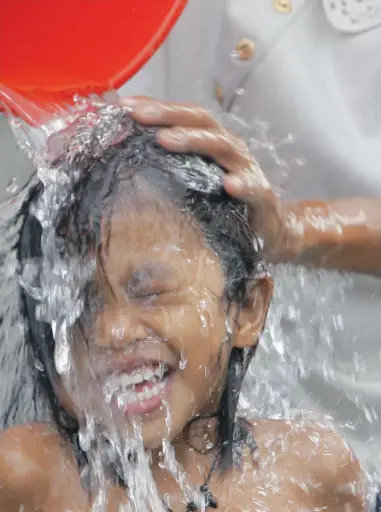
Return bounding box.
[122,0,381,474]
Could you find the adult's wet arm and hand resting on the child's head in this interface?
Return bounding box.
[121,98,381,275]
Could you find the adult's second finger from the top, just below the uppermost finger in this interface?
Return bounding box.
[157,128,252,173]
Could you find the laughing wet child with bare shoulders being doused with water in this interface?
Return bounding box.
[0,107,365,512]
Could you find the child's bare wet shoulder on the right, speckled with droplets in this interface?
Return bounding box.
[249,418,366,511]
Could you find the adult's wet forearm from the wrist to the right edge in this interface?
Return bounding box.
[278,198,381,274]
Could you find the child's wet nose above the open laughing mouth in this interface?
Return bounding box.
[96,304,149,348]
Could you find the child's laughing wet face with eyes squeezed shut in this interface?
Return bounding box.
[65,189,266,449]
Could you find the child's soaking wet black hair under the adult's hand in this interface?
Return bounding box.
[18,113,261,474]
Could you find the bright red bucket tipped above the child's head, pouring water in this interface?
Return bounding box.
[0,0,188,123]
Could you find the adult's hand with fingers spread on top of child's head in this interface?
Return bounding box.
[121,97,292,261]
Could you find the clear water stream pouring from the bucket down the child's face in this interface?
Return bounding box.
[2,98,172,512]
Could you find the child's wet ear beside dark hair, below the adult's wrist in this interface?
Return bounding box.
[234,275,273,348]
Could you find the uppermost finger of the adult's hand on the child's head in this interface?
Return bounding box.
[121,97,218,128]
